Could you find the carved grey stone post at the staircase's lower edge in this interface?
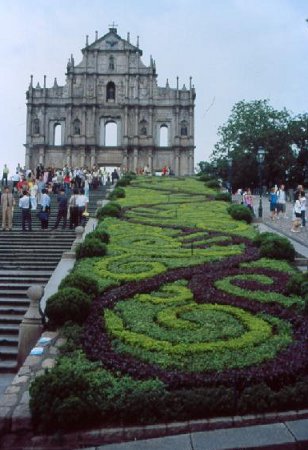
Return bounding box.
[17,285,44,367]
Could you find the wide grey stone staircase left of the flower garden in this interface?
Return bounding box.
[0,187,106,373]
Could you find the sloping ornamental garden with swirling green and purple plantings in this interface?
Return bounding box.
[30,175,308,432]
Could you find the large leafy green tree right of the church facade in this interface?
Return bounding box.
[211,100,302,188]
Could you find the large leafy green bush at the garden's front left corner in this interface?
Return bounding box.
[30,352,165,432]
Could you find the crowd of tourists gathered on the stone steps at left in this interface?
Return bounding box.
[1,164,121,231]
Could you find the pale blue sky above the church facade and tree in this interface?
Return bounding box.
[0,0,308,176]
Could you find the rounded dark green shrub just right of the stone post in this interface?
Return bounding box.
[45,287,91,327]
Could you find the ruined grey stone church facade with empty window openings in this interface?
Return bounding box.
[25,26,195,175]
